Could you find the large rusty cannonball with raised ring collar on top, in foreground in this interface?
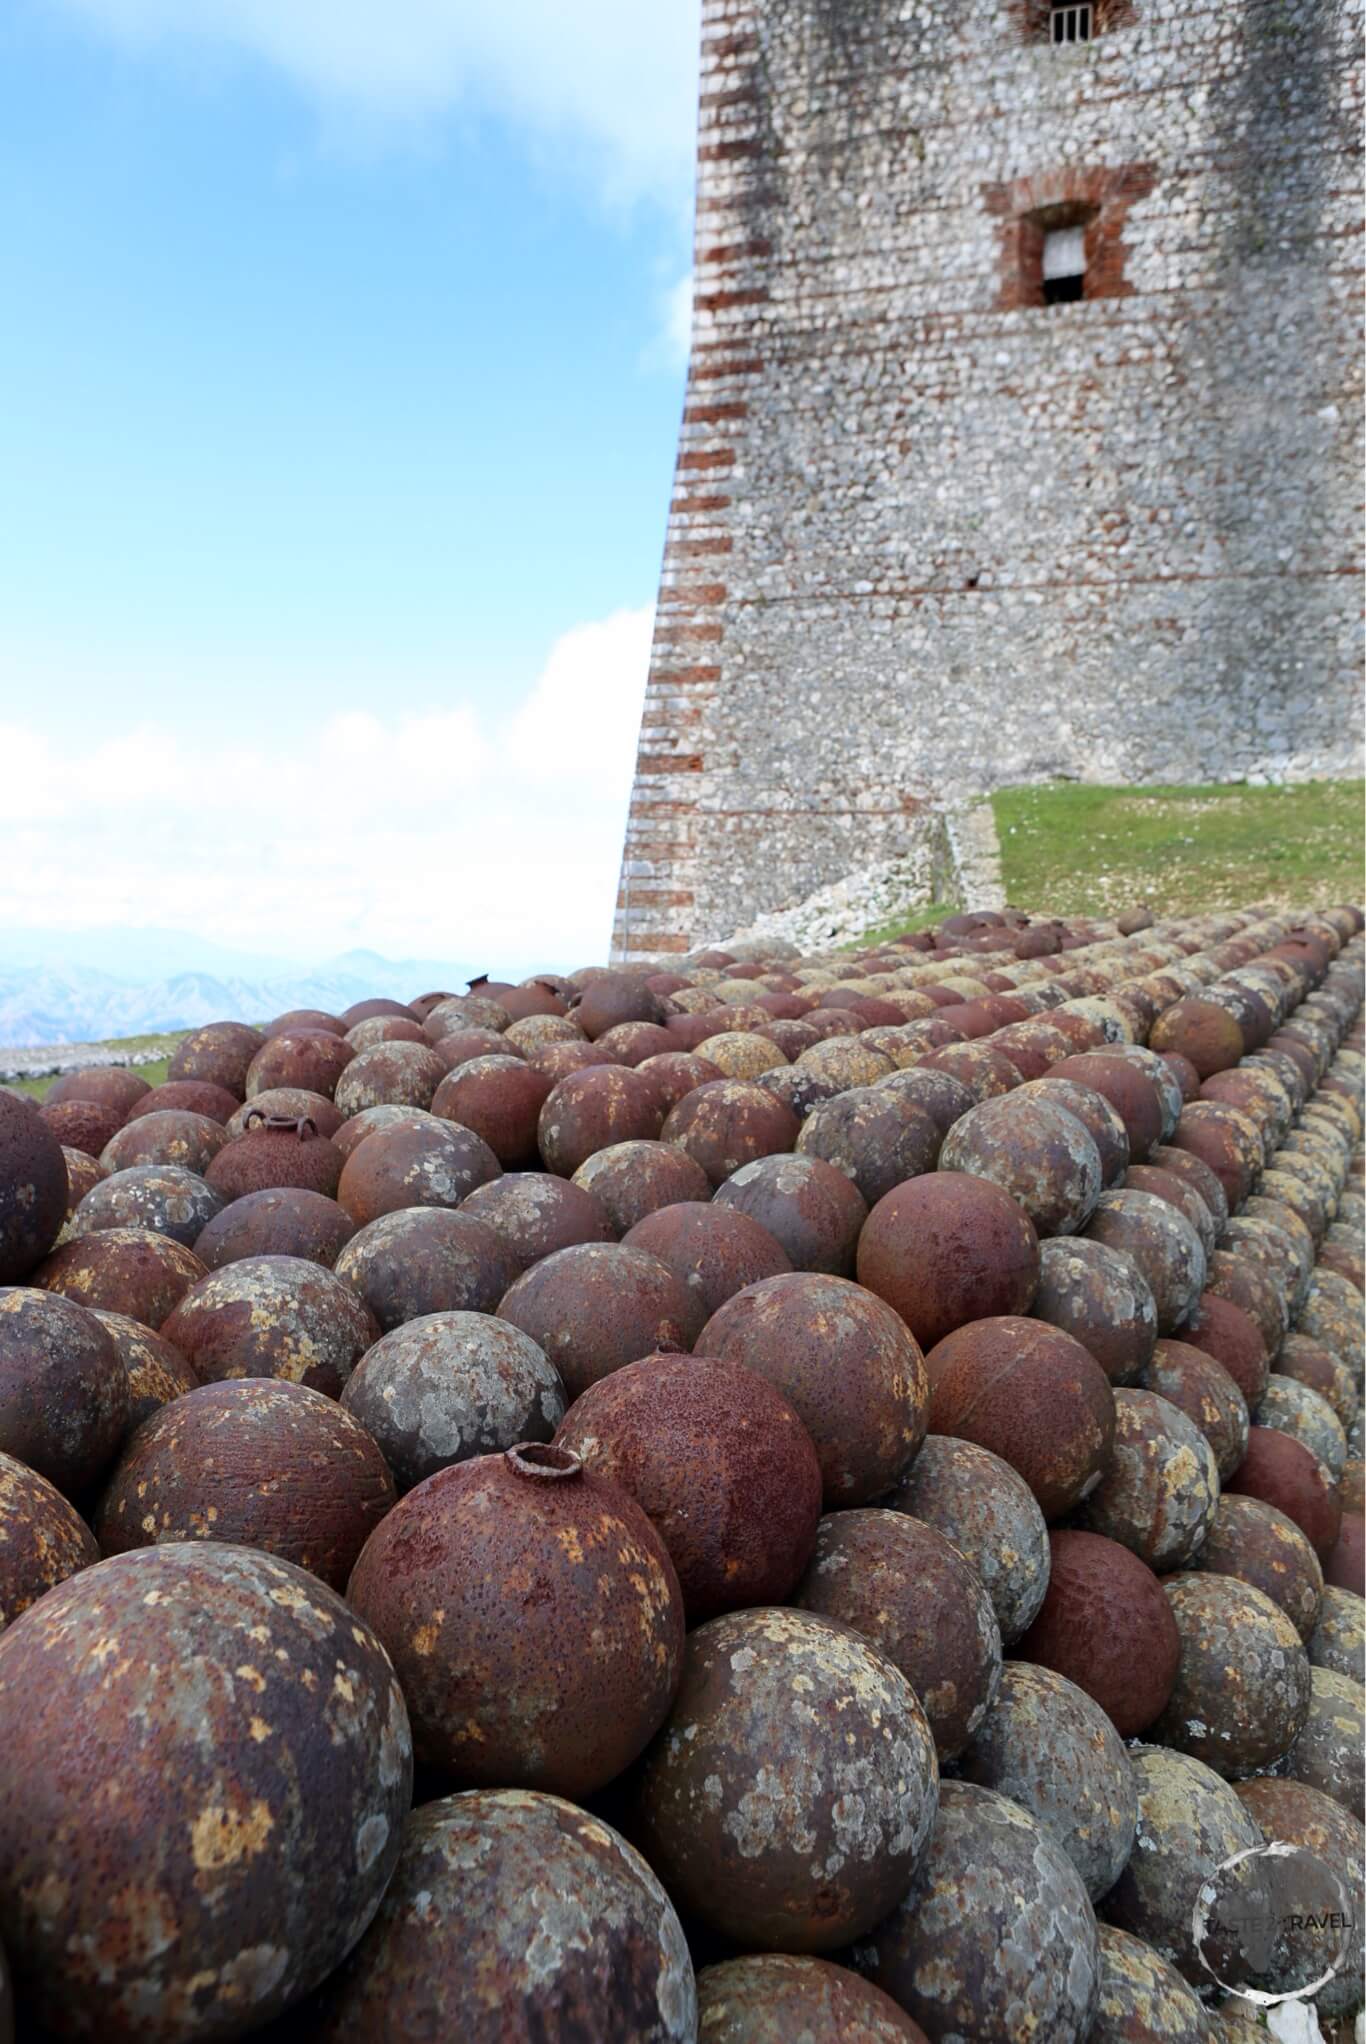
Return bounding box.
[348,1441,683,1797]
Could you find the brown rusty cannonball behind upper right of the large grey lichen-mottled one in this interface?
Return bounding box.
[791,1508,1002,1762]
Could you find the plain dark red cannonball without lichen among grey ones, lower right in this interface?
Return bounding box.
[1018,1529,1182,1739]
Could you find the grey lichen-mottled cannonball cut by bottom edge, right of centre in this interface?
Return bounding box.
[853,1780,1100,2044]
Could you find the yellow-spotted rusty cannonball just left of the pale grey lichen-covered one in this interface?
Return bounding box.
[162,1257,378,1398]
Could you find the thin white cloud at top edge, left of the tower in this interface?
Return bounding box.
[55,0,699,204]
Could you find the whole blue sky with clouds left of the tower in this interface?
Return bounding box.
[0,0,695,967]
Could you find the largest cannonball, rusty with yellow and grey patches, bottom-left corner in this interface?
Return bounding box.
[0,1541,413,2044]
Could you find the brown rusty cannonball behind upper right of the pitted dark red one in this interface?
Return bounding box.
[695,1271,928,1511]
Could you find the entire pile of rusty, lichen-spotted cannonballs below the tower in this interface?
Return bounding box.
[0,908,1366,2044]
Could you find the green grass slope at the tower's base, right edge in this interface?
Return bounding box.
[992,781,1366,916]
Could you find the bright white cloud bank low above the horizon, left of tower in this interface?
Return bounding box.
[0,607,652,971]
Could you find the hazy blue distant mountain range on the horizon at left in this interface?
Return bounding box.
[0,932,483,1047]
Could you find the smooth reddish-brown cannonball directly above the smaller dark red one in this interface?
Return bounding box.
[924,1314,1114,1519]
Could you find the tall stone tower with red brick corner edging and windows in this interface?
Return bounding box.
[616,0,1362,957]
